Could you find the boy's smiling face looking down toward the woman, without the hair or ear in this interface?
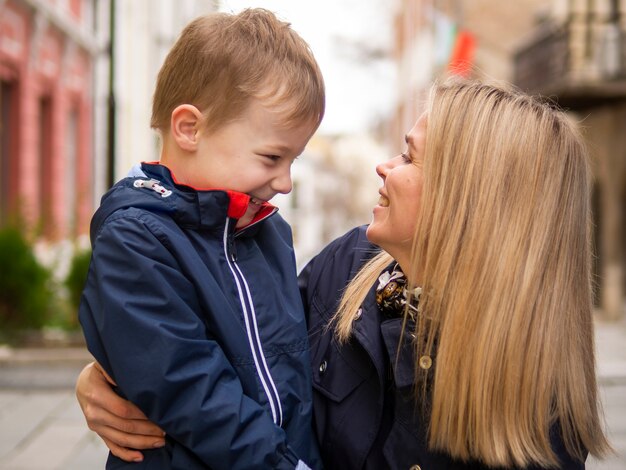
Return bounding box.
[185,99,317,227]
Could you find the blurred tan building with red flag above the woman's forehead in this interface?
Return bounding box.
[391,0,547,142]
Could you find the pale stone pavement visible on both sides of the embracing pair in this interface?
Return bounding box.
[0,319,626,470]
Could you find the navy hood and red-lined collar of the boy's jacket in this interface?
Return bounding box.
[90,163,278,243]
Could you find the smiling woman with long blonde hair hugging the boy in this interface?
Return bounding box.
[78,82,610,469]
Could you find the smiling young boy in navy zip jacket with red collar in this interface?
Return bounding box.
[80,9,324,469]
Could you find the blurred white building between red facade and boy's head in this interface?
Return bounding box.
[106,0,218,182]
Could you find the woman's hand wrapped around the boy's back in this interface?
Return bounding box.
[76,362,165,462]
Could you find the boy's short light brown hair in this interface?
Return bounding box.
[150,8,325,132]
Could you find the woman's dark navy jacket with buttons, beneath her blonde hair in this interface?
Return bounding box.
[300,227,584,470]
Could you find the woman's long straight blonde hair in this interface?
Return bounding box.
[334,81,610,467]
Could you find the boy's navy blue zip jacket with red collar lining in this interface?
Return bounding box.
[80,163,319,470]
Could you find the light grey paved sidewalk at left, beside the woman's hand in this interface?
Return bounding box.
[0,347,107,470]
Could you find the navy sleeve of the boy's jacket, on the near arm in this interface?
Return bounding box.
[80,215,308,469]
